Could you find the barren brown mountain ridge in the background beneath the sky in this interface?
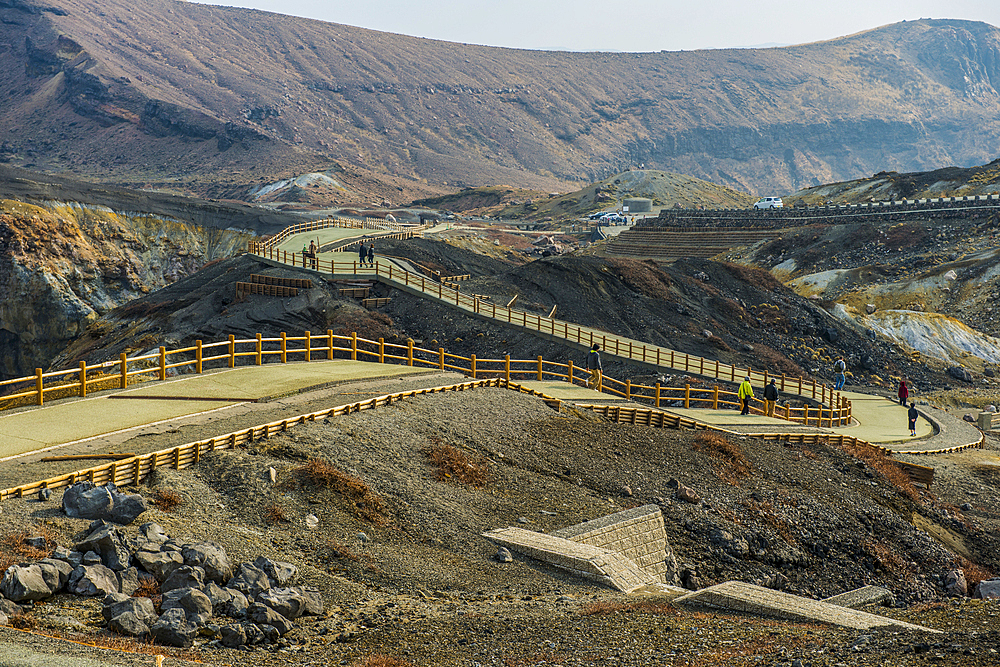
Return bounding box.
[0,0,1000,200]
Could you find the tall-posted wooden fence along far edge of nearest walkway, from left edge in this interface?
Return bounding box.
[0,328,851,426]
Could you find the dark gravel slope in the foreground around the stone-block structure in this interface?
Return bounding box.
[0,388,1000,667]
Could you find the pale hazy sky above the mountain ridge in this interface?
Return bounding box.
[193,0,1000,51]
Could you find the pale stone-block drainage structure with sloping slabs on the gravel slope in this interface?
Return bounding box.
[483,505,940,634]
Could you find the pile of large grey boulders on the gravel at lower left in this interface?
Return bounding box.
[0,519,323,648]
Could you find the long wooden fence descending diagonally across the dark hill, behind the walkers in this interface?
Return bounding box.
[250,240,851,423]
